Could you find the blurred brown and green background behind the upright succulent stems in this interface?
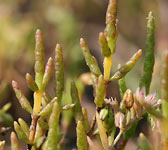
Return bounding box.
[0,0,168,150]
